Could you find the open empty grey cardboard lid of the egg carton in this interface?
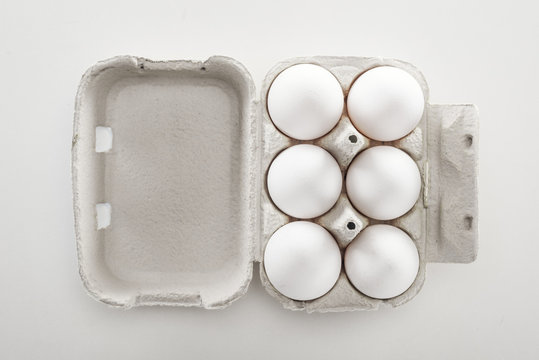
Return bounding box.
[72,56,258,308]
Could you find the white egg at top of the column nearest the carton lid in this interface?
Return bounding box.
[267,64,344,140]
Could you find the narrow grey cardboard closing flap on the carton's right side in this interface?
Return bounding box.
[425,105,479,263]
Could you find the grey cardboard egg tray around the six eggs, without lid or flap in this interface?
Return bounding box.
[258,57,428,312]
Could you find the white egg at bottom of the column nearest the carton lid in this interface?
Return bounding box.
[264,221,341,301]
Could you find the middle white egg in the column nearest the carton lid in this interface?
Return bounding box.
[267,144,342,219]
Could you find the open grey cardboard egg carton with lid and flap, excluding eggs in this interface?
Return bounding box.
[72,56,478,312]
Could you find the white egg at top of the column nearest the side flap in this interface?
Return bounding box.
[346,66,425,141]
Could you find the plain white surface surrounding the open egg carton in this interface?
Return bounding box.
[0,0,539,360]
